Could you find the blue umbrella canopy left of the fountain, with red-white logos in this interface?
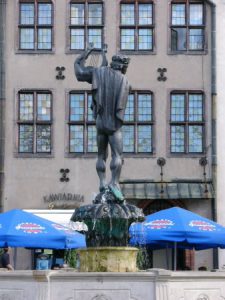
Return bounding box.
[0,209,86,249]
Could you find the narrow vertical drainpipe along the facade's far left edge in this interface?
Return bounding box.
[0,0,6,212]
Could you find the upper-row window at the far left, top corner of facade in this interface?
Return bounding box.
[19,0,53,50]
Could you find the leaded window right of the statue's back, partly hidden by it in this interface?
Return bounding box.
[123,92,153,153]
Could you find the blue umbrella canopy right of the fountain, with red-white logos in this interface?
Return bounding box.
[129,207,225,250]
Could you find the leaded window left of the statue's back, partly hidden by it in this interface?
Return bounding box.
[69,92,97,153]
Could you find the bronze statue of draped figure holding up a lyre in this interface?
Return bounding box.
[74,47,130,201]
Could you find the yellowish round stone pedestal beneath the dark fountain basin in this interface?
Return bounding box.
[79,247,138,272]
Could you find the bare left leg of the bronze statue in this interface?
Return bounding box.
[96,131,108,192]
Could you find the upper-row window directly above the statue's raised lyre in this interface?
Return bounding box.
[70,0,103,50]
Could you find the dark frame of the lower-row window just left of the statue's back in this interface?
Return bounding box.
[66,89,97,158]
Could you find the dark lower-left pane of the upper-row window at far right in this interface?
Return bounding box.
[171,28,187,51]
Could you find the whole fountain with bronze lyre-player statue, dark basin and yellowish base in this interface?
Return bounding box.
[71,45,144,272]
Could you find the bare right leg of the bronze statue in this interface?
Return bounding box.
[109,128,123,190]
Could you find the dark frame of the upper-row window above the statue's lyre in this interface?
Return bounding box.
[66,0,105,54]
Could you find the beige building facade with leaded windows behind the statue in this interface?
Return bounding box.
[1,0,221,268]
